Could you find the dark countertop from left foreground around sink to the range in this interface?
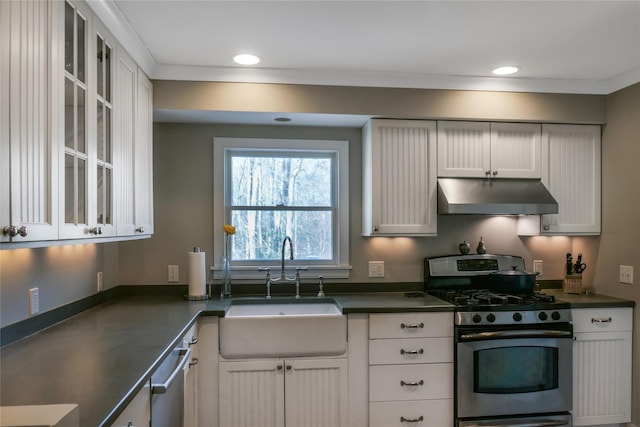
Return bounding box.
[0,292,453,427]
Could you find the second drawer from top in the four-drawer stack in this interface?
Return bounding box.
[369,337,453,365]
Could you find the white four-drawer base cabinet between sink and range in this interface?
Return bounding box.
[369,313,454,427]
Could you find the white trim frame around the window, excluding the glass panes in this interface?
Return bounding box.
[211,137,351,281]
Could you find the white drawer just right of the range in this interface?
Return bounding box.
[571,307,633,332]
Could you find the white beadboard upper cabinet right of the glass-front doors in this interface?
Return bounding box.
[114,48,153,241]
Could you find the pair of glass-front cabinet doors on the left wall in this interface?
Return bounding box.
[60,2,115,239]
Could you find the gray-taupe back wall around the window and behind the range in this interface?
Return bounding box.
[120,123,584,290]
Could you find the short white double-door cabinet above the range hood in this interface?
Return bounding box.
[438,121,542,178]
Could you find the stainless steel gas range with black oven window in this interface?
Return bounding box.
[424,254,573,427]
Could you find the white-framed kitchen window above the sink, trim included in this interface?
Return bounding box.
[214,138,349,279]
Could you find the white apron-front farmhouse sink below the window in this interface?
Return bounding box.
[220,300,347,359]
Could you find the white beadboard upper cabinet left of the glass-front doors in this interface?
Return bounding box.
[0,1,62,242]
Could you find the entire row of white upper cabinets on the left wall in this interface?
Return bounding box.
[0,0,153,247]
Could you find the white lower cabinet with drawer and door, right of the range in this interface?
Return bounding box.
[572,307,633,426]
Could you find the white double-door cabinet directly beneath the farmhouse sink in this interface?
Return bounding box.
[219,358,348,427]
